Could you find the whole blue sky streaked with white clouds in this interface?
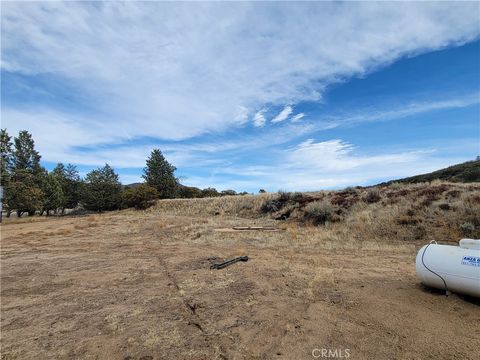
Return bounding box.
[1,2,480,192]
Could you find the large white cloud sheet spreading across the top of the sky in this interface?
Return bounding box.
[1,2,480,145]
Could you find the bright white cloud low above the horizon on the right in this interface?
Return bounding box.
[212,139,476,191]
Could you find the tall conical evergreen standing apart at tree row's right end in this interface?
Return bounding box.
[143,149,178,199]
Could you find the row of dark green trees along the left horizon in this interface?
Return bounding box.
[0,129,251,217]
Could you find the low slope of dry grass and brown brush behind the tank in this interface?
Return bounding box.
[150,180,480,243]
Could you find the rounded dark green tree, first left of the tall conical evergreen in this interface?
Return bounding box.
[82,164,122,211]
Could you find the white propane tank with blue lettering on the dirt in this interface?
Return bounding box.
[416,239,480,298]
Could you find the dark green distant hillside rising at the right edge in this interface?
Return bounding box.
[388,159,480,184]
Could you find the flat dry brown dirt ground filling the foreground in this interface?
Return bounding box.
[1,211,480,360]
